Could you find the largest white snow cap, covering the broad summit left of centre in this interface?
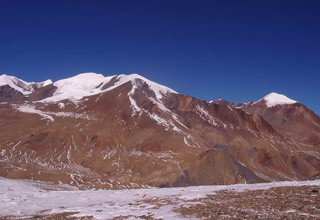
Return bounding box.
[42,72,176,102]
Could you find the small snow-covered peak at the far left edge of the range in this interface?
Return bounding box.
[0,74,33,94]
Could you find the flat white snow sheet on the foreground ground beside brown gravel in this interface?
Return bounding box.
[0,178,320,219]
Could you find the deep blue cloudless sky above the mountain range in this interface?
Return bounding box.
[0,0,320,113]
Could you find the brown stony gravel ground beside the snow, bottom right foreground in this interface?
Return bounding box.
[177,186,320,219]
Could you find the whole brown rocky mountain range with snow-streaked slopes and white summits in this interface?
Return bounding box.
[0,73,320,188]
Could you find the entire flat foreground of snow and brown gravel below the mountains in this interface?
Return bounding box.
[0,178,320,219]
